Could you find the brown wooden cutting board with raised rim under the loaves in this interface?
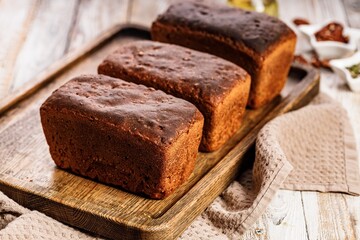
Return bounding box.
[0,26,319,239]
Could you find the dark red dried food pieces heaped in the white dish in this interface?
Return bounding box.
[315,22,349,43]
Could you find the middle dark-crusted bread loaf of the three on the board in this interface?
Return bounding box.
[98,41,250,151]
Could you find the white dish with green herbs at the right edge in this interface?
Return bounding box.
[329,51,360,92]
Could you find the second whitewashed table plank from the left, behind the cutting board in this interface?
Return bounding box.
[11,0,77,91]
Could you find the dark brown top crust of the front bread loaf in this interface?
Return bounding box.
[41,75,203,145]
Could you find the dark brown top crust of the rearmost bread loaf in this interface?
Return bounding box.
[155,2,296,55]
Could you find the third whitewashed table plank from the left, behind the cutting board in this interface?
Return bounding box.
[67,0,129,51]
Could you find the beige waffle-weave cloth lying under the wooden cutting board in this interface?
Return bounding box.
[0,95,360,240]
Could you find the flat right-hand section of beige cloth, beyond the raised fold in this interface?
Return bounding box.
[282,95,360,195]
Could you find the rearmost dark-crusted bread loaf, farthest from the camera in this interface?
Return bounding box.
[151,2,296,108]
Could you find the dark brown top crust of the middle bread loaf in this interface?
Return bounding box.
[98,40,249,107]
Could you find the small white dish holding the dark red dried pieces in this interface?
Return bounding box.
[299,22,360,60]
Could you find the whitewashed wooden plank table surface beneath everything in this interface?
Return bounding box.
[0,0,360,239]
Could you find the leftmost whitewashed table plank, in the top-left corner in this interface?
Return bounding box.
[0,0,36,97]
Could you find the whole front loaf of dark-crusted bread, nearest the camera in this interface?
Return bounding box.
[40,75,204,199]
